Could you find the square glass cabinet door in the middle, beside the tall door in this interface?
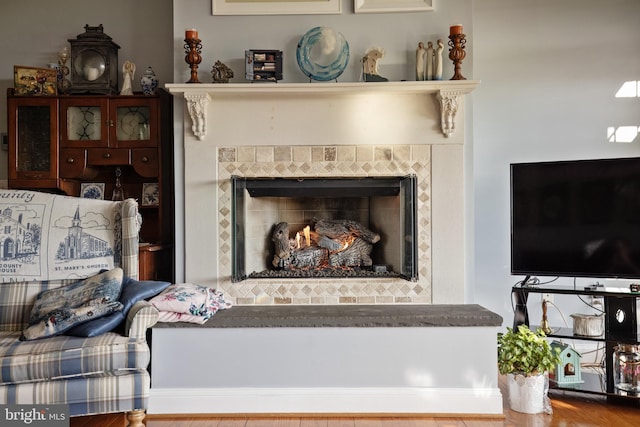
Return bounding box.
[60,97,109,148]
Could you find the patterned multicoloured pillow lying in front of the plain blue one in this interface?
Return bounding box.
[22,268,123,339]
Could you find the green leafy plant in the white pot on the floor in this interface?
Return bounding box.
[498,325,560,376]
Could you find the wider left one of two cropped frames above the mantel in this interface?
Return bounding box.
[211,0,342,15]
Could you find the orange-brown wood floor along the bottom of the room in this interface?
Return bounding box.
[70,384,640,427]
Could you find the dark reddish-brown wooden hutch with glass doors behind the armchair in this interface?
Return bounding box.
[7,89,174,282]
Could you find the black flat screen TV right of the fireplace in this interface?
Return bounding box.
[511,158,640,278]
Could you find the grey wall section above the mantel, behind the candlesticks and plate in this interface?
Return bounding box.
[173,0,473,83]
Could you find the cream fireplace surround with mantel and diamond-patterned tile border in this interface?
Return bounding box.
[167,81,479,305]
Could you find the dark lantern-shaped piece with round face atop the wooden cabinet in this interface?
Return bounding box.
[69,24,120,94]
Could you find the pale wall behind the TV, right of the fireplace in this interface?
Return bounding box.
[473,0,640,326]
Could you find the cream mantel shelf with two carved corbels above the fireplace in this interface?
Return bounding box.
[165,80,480,140]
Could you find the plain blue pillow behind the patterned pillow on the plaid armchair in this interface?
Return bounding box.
[65,277,171,337]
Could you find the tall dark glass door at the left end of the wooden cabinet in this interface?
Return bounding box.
[8,98,58,188]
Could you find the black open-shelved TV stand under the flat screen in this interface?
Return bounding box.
[512,282,640,406]
